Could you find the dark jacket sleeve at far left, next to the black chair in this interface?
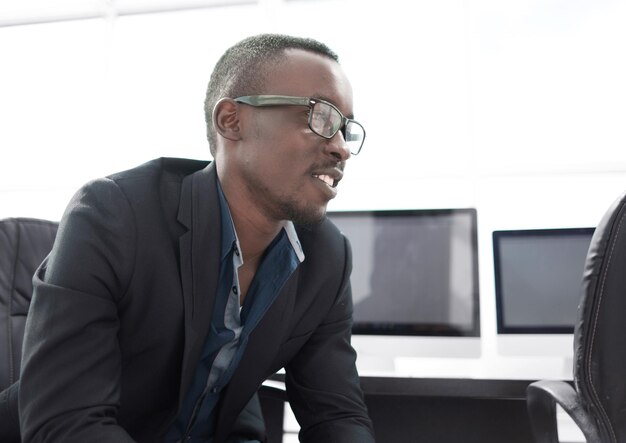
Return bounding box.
[19,179,136,443]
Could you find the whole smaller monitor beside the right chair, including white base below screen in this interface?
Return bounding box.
[493,228,594,379]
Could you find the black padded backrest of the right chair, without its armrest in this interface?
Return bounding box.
[574,194,626,443]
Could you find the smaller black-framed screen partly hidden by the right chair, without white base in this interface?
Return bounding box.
[493,228,594,334]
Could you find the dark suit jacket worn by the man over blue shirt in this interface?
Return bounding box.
[19,159,373,443]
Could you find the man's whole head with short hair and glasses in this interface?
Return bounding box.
[206,35,365,227]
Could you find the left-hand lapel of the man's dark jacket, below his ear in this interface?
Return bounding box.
[178,163,222,406]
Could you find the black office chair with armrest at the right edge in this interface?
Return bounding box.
[527,193,626,443]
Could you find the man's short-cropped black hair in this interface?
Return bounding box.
[204,34,339,157]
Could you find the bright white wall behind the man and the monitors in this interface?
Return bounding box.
[0,0,626,372]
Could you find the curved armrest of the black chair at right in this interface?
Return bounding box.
[526,380,600,443]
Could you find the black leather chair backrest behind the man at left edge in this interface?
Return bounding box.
[0,218,58,390]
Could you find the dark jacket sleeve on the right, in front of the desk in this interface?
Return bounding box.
[285,234,374,443]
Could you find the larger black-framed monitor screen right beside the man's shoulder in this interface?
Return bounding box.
[328,208,480,337]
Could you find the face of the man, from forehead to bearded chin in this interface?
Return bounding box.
[237,50,352,224]
